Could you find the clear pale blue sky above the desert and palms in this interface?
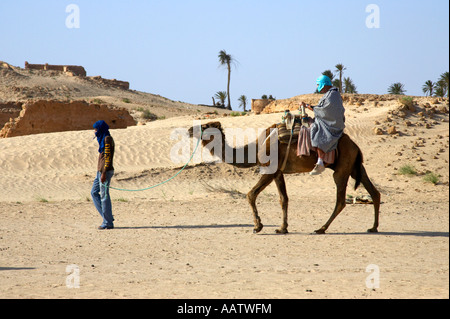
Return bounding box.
[0,0,449,109]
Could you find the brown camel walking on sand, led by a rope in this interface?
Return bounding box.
[189,121,381,234]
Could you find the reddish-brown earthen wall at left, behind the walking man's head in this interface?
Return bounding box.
[0,100,136,138]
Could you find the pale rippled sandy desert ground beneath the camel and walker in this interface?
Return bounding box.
[0,98,449,299]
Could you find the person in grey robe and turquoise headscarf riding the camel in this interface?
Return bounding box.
[301,75,345,175]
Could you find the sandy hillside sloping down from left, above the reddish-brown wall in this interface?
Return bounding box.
[0,61,230,126]
